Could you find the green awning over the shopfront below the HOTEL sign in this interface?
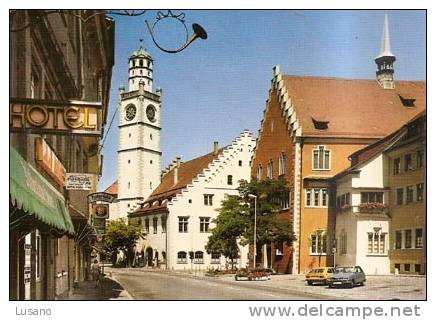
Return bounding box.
[9,146,74,235]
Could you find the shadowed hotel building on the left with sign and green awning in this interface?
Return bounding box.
[9,10,115,300]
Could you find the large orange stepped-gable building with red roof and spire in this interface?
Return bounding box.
[252,13,425,273]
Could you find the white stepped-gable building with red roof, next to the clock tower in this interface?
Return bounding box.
[129,131,255,270]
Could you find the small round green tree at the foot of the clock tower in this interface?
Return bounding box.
[103,219,144,265]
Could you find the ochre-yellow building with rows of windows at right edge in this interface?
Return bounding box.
[385,113,427,274]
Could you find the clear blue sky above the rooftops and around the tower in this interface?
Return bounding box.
[99,10,426,190]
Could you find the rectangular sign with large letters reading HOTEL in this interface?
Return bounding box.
[9,98,102,135]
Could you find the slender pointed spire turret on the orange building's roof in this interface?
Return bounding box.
[375,12,395,89]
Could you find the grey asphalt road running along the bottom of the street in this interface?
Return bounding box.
[109,269,322,300]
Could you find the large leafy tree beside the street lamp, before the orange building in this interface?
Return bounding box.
[206,179,295,268]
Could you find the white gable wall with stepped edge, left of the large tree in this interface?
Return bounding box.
[141,132,255,270]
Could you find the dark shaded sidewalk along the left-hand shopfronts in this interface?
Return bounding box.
[60,277,132,301]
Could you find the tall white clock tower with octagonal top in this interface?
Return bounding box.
[118,47,162,217]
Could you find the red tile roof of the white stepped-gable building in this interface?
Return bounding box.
[131,149,223,216]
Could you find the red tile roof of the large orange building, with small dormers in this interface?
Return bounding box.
[283,75,426,137]
